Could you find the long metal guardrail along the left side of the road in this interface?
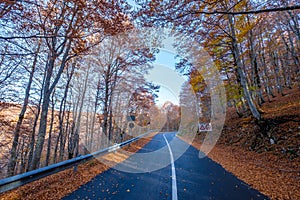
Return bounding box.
[0,131,152,193]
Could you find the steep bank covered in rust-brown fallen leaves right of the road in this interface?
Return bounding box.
[180,89,300,200]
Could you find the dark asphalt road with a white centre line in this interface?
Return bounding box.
[64,133,268,200]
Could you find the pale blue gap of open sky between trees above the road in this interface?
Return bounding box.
[146,49,186,105]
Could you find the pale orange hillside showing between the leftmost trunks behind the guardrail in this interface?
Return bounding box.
[0,102,63,179]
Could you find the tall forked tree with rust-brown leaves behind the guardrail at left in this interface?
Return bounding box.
[27,1,132,169]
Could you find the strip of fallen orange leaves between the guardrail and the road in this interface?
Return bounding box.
[0,133,156,200]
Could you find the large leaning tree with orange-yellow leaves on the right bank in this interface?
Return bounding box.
[138,1,299,120]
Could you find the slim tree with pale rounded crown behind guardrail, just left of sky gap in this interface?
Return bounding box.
[90,32,154,147]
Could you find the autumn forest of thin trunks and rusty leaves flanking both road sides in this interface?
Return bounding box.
[0,0,300,178]
